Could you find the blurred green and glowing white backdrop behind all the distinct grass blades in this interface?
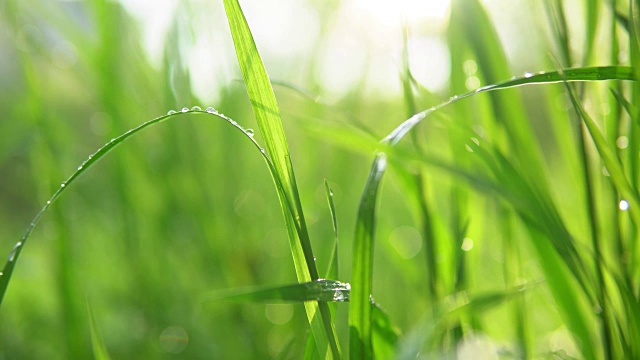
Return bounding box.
[0,0,634,359]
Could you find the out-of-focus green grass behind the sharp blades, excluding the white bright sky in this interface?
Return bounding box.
[0,0,640,359]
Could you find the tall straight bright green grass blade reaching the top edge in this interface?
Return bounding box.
[224,0,341,358]
